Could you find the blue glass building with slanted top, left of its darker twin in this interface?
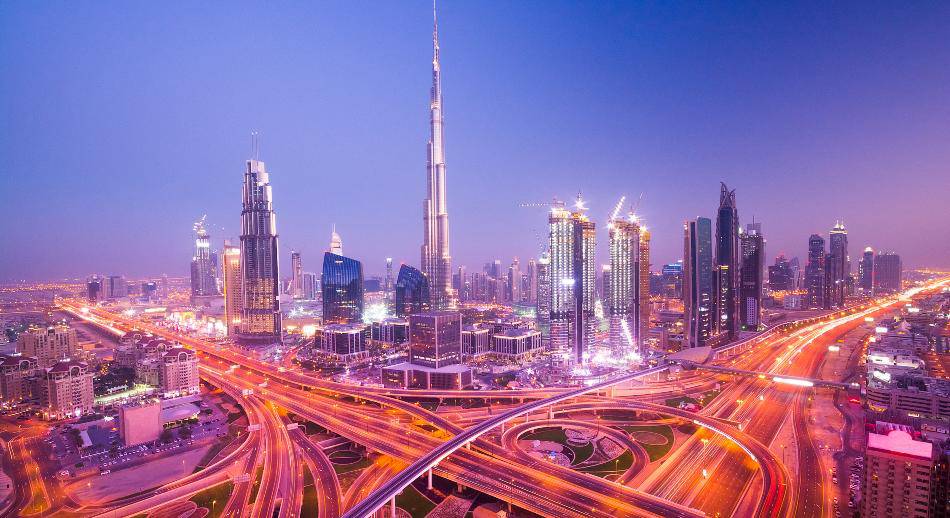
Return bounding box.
[320,252,363,324]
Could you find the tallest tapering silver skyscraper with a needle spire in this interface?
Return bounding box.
[422,6,458,309]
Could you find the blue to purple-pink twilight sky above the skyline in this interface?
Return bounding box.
[0,0,950,280]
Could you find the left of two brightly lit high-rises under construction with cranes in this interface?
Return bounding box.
[548,197,597,363]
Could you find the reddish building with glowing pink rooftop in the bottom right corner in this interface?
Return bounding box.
[861,430,947,518]
